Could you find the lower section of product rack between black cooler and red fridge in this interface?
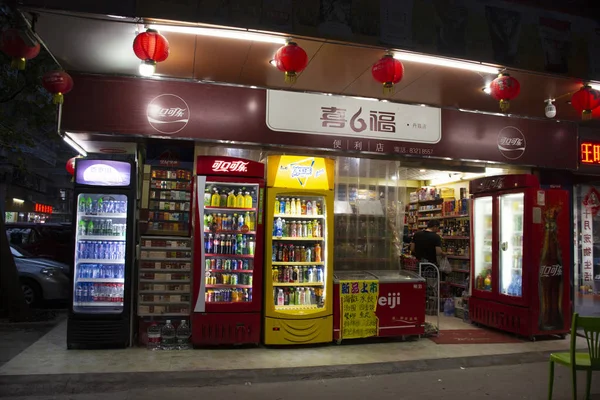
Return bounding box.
[137,236,192,317]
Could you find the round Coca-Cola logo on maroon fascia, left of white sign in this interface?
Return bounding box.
[146,94,190,135]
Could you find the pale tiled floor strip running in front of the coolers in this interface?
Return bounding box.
[0,316,583,375]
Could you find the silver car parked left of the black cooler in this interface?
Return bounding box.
[10,245,70,305]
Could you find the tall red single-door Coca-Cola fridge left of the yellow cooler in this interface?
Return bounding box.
[192,156,265,346]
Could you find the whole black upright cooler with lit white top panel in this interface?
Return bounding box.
[67,159,135,348]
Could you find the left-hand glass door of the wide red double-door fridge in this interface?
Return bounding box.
[473,196,493,292]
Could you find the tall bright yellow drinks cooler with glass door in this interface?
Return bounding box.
[264,156,334,345]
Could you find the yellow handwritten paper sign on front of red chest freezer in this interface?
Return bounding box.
[340,280,379,339]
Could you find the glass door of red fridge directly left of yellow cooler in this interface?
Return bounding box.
[201,182,261,304]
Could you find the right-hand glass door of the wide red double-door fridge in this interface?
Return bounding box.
[498,193,525,297]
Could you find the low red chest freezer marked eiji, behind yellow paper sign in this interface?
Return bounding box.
[333,271,427,341]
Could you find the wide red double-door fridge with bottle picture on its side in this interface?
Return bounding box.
[469,175,571,340]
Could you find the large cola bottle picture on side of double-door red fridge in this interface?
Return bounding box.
[539,207,563,331]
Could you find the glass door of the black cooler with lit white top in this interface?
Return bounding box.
[73,193,127,314]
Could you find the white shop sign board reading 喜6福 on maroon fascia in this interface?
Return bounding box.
[267,90,442,144]
